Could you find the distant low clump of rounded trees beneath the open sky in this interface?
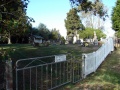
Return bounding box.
[30,23,63,42]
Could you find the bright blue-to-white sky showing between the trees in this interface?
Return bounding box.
[27,0,117,37]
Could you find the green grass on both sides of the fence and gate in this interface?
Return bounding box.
[0,44,120,90]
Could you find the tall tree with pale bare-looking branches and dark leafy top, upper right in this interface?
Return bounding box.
[77,0,108,28]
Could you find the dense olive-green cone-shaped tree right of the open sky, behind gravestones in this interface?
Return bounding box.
[65,8,83,35]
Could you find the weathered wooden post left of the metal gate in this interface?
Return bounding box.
[5,60,13,90]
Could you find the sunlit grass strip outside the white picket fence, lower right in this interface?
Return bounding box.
[63,48,120,90]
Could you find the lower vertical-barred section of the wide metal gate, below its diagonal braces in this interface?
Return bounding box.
[16,61,71,90]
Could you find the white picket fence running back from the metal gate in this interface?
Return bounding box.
[82,38,114,78]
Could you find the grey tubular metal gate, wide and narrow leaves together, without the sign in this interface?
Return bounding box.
[16,55,81,90]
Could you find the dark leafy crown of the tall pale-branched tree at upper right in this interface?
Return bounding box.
[78,0,108,20]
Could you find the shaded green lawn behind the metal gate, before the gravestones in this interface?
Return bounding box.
[0,44,98,61]
